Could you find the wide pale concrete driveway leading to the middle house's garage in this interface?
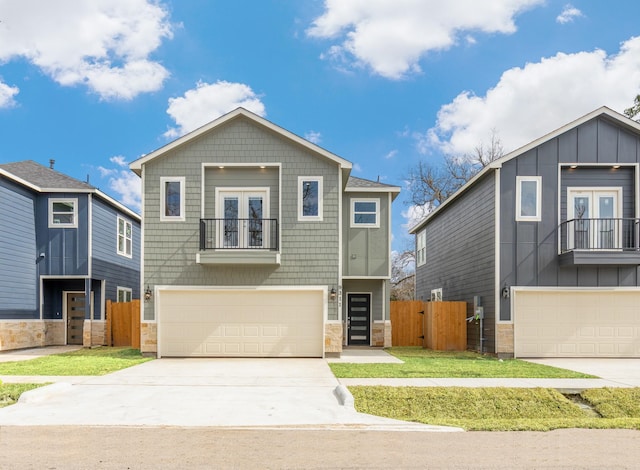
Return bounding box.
[0,359,459,431]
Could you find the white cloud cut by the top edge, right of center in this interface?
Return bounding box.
[307,0,544,79]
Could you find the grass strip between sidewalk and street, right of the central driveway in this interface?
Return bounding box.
[349,386,640,431]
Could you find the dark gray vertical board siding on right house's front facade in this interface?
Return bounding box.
[500,118,640,321]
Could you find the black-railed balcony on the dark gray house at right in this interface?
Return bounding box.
[560,218,640,266]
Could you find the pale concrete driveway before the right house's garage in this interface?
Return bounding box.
[525,358,640,387]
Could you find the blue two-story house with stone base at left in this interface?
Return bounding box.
[0,160,140,350]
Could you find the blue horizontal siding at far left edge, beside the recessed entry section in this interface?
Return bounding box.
[0,179,40,319]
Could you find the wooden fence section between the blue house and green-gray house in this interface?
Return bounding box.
[105,300,140,349]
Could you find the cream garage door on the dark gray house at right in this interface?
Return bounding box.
[514,291,640,357]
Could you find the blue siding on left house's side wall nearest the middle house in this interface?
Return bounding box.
[91,197,141,301]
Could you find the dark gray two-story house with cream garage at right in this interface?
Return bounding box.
[411,107,640,357]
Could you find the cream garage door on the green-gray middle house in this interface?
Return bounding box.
[158,290,324,357]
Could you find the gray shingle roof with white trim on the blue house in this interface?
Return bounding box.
[0,160,141,222]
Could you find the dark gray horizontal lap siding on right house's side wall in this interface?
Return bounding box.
[416,172,495,352]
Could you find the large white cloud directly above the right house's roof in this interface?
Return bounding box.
[418,37,640,155]
